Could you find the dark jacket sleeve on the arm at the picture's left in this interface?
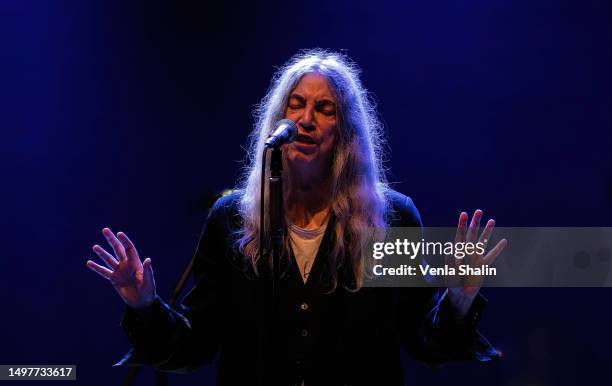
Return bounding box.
[114,198,233,373]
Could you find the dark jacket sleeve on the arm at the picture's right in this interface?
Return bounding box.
[399,197,501,366]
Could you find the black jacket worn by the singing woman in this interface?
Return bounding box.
[117,188,499,386]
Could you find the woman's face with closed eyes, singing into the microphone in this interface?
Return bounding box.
[285,73,336,177]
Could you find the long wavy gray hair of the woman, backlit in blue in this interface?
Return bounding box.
[236,49,390,289]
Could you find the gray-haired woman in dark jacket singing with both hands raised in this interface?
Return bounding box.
[87,50,506,386]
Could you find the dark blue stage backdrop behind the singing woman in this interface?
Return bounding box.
[0,0,612,386]
